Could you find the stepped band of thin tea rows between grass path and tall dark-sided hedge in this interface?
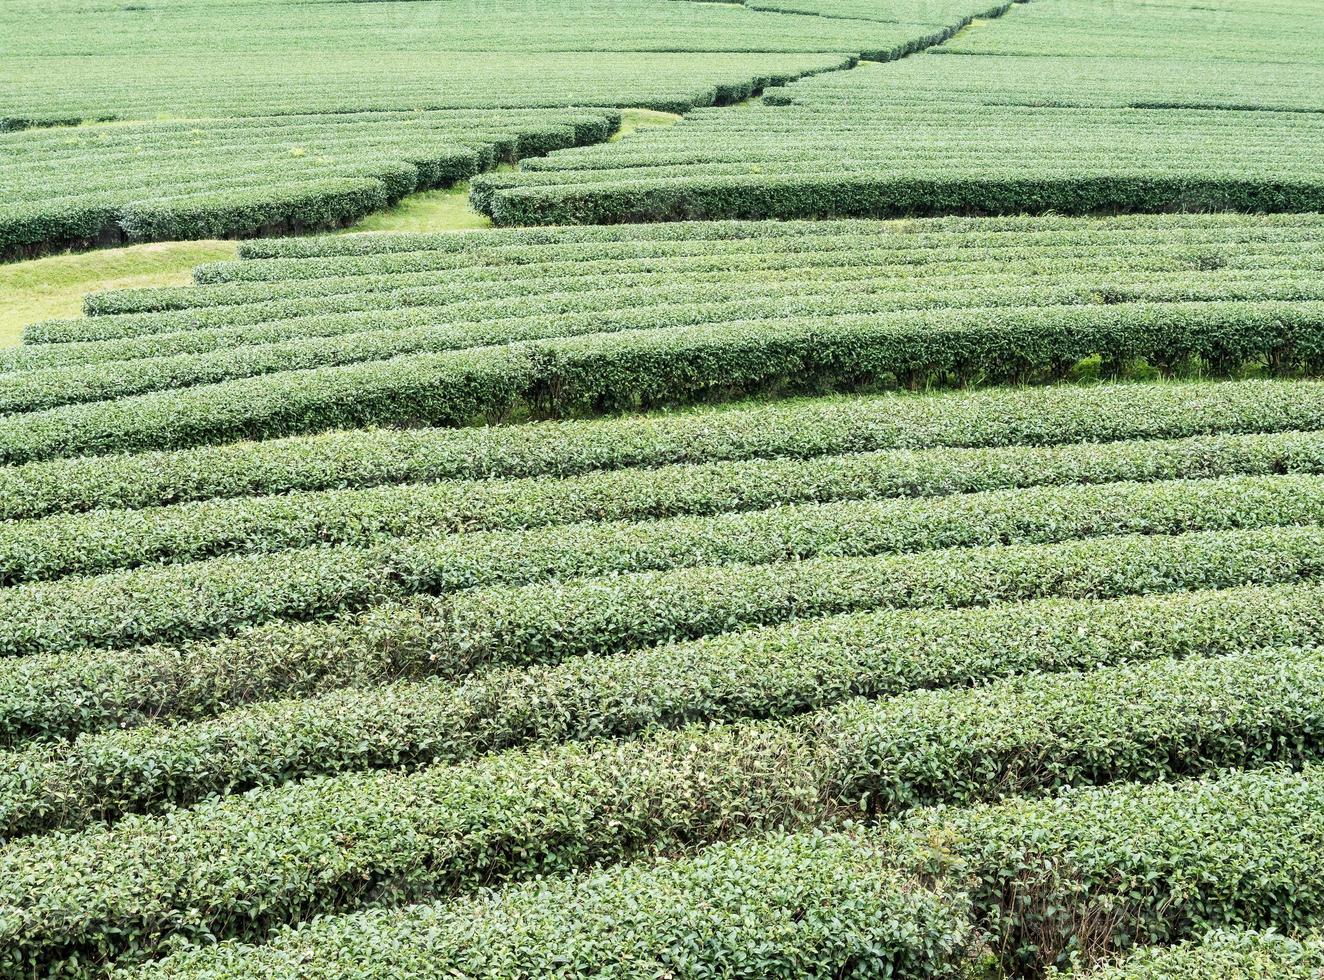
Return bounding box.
[3,219,1321,376]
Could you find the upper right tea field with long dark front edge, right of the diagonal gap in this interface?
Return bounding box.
[474,0,1324,224]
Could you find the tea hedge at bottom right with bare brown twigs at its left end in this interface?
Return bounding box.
[926,765,1324,976]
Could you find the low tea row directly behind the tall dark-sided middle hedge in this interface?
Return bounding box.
[0,269,1324,389]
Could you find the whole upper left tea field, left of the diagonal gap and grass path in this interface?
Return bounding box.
[0,0,1011,261]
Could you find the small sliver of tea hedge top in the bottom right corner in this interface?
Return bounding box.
[1090,930,1324,980]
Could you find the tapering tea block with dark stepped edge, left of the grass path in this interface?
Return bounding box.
[0,110,620,258]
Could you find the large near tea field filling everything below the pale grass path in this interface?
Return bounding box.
[0,215,1324,976]
